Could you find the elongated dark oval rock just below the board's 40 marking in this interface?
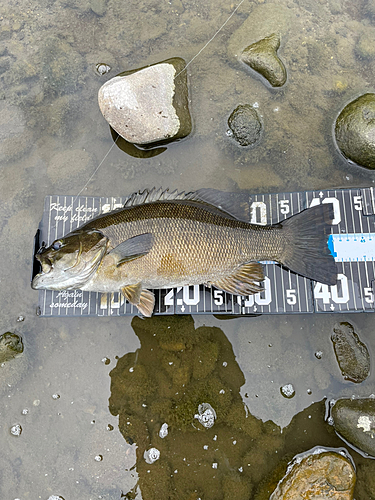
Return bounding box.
[331,321,370,383]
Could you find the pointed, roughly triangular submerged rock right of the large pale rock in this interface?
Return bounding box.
[241,33,287,87]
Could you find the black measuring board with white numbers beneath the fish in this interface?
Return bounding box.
[33,187,375,316]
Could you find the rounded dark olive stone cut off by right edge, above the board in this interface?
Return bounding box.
[335,94,375,169]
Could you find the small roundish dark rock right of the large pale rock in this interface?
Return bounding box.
[228,104,263,146]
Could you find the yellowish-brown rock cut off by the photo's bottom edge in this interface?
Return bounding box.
[270,448,356,500]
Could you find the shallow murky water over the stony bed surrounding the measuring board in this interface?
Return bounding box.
[0,0,375,500]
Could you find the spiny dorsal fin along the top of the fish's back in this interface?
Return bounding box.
[124,188,249,222]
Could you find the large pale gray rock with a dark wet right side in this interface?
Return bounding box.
[98,58,191,144]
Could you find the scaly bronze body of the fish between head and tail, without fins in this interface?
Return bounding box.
[87,202,280,291]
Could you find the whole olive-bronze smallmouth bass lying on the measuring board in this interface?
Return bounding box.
[31,189,337,316]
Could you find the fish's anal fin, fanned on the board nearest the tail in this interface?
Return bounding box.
[210,262,264,295]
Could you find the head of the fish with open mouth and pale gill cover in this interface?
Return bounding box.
[31,229,108,290]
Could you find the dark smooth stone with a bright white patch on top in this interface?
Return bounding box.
[330,398,375,458]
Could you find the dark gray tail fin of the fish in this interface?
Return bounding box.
[281,204,337,285]
